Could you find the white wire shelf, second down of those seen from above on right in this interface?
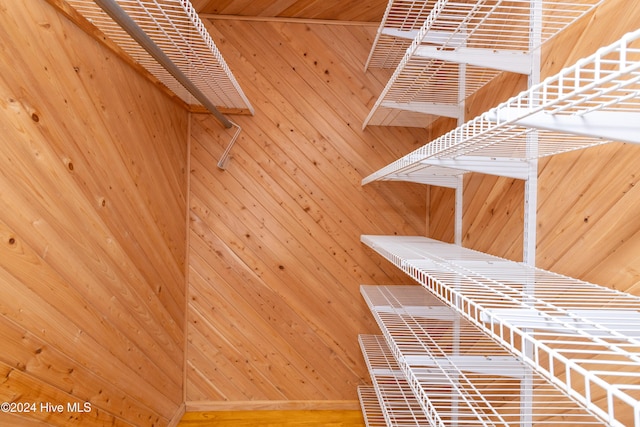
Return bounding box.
[362,286,603,427]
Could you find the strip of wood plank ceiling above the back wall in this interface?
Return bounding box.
[192,0,387,23]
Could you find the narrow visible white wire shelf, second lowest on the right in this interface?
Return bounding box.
[358,335,433,427]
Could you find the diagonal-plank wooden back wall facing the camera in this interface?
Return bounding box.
[187,20,428,410]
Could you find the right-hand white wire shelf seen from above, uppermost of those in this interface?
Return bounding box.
[362,236,640,427]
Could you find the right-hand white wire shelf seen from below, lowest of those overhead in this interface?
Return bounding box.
[362,26,640,184]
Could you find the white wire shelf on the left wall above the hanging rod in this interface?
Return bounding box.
[68,0,254,114]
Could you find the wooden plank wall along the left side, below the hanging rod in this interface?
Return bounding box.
[0,0,188,426]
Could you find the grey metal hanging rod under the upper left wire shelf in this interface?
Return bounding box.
[95,0,232,129]
